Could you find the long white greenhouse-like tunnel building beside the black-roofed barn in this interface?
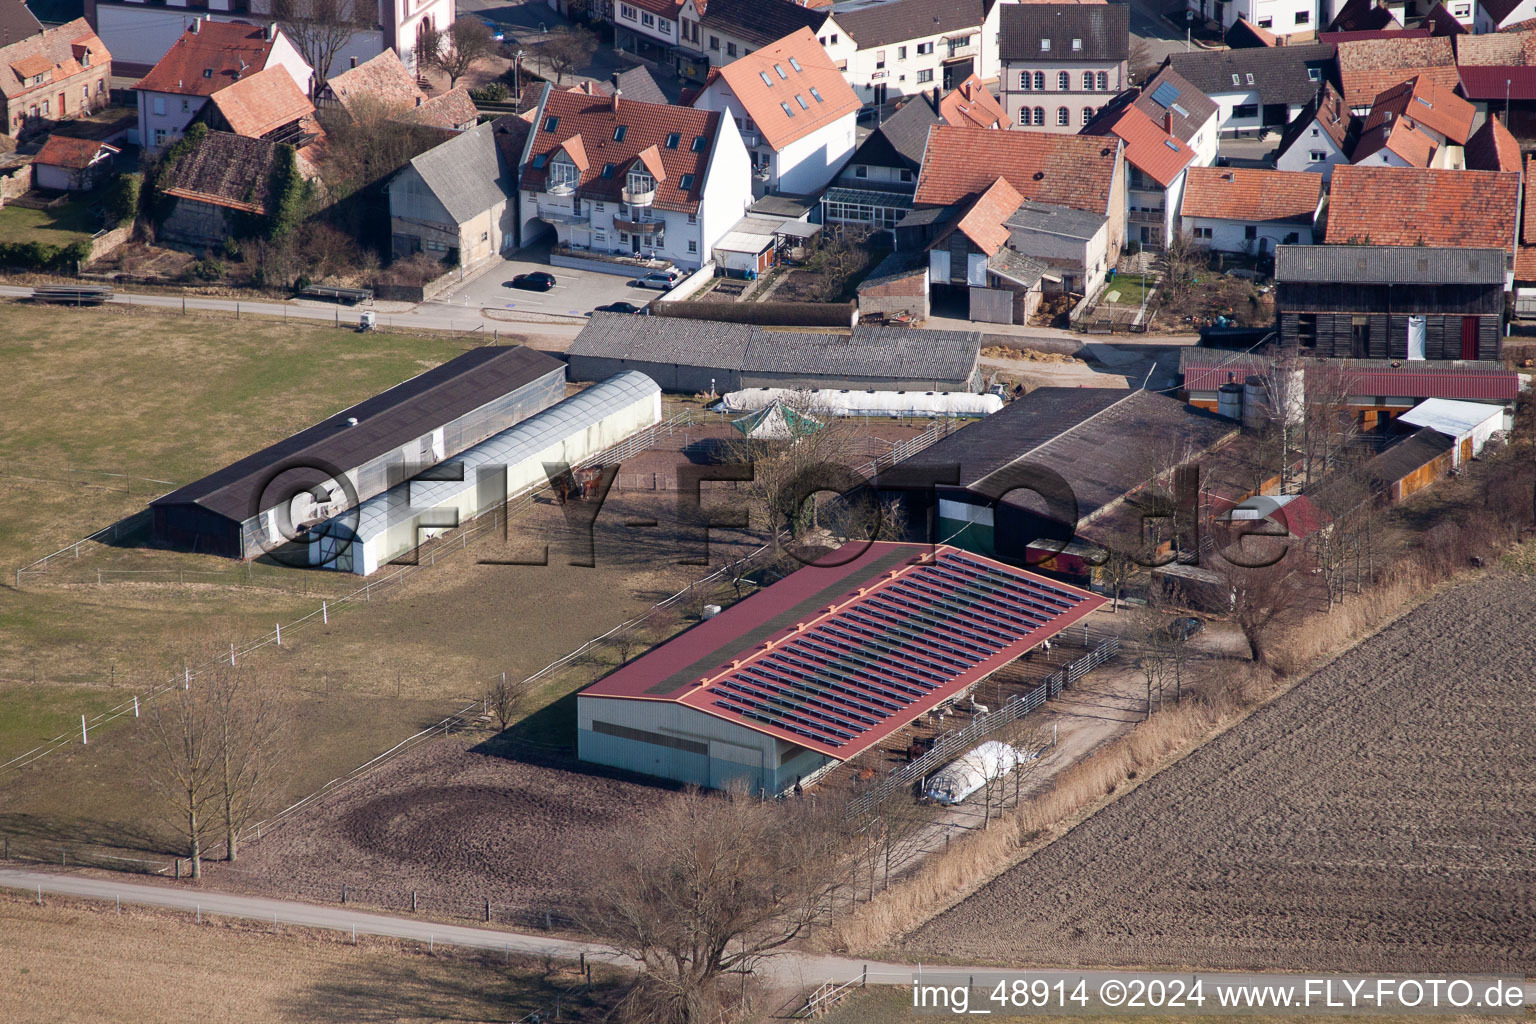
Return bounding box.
[309,370,662,576]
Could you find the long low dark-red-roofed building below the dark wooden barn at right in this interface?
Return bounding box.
[1178,348,1521,430]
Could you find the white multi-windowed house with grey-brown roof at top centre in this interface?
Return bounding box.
[817,0,1003,104]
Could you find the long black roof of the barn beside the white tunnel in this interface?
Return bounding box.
[151,345,562,522]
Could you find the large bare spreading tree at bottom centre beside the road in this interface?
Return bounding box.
[587,789,848,1024]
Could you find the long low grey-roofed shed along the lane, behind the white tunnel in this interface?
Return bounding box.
[567,313,982,393]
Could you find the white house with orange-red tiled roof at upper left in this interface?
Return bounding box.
[134,18,313,149]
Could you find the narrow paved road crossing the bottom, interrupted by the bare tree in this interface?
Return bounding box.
[0,867,1536,1004]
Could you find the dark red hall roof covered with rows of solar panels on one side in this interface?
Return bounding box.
[581,542,1104,760]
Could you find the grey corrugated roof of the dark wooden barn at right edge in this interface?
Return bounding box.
[1275,246,1505,284]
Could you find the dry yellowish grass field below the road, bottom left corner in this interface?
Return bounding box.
[0,897,614,1024]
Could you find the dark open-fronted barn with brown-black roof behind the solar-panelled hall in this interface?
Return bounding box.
[880,387,1240,574]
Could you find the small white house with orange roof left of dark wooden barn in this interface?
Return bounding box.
[1180,167,1322,256]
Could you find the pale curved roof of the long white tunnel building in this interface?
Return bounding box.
[330,370,662,543]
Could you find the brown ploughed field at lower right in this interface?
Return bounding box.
[908,574,1536,973]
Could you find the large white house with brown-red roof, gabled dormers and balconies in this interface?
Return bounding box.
[519,86,753,269]
